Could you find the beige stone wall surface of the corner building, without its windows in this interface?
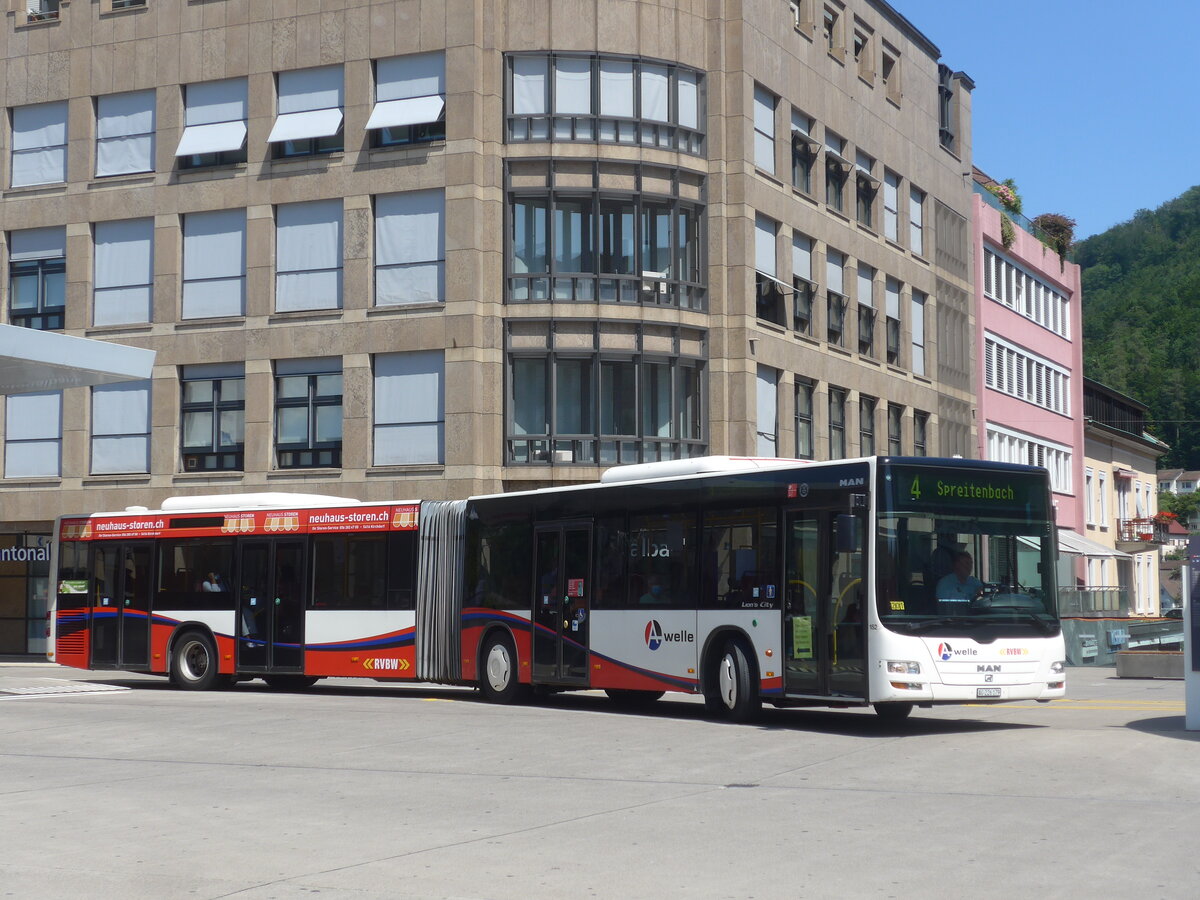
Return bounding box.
[0,0,976,532]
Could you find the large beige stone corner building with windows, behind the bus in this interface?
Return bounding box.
[0,0,976,652]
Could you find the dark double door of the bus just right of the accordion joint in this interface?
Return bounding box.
[533,524,592,685]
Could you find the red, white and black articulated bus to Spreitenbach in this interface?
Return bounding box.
[49,457,1066,721]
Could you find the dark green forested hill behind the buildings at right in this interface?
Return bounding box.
[1072,186,1200,469]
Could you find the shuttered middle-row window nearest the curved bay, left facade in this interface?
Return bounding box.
[374,188,445,306]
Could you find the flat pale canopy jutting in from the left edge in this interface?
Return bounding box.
[0,325,155,394]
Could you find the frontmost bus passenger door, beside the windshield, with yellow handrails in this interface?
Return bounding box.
[784,510,868,698]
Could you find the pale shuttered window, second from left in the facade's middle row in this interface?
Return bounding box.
[92,218,154,325]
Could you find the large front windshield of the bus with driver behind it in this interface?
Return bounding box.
[876,468,1058,640]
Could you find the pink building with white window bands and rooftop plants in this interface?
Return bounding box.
[972,177,1085,540]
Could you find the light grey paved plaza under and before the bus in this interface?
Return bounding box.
[0,664,1200,900]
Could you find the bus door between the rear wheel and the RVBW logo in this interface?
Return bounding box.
[236,540,305,672]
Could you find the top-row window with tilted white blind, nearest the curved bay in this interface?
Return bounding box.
[367,50,446,146]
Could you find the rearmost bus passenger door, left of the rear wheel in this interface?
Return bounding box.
[91,544,151,670]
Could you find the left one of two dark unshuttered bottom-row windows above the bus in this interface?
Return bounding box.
[180,362,246,472]
